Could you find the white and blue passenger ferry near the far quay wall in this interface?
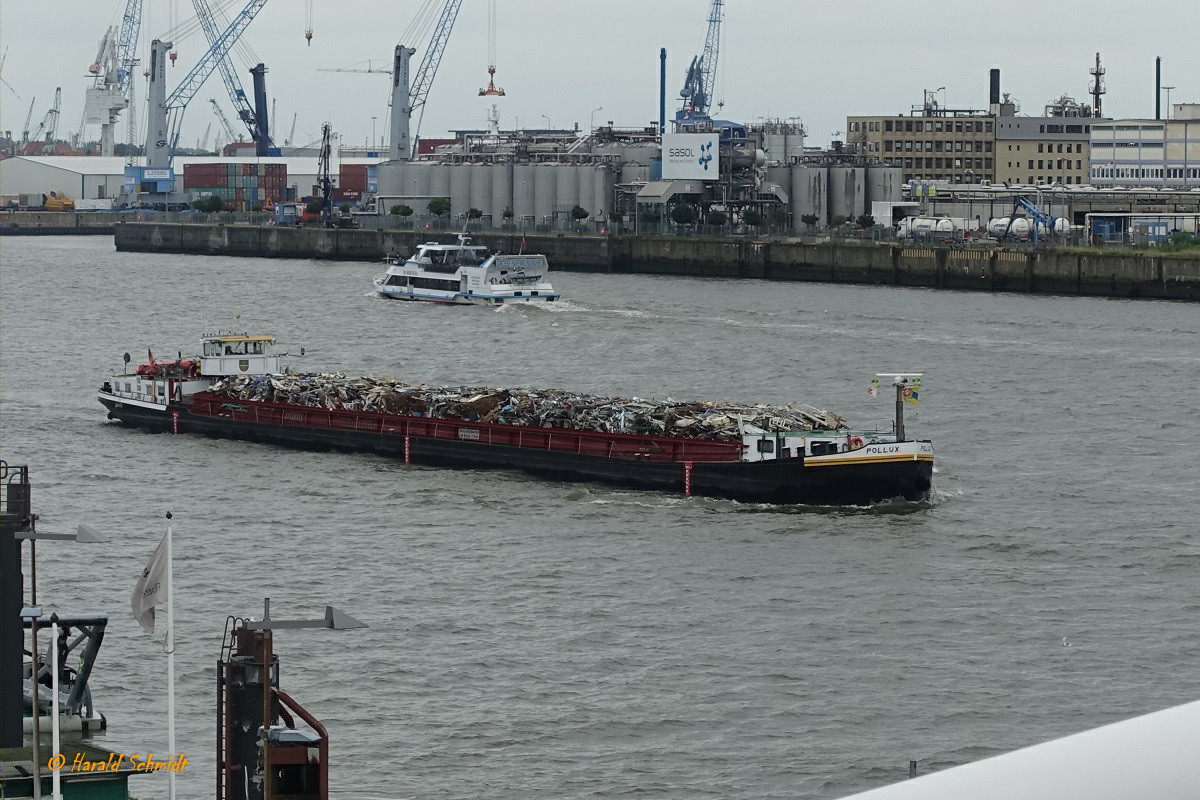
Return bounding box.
[374,234,558,306]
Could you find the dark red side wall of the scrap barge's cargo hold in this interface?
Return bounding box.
[191,392,742,462]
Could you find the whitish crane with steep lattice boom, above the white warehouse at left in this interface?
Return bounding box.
[84,0,143,156]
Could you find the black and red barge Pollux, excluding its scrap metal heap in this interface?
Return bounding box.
[97,333,934,505]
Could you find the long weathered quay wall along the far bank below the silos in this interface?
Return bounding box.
[114,221,1200,300]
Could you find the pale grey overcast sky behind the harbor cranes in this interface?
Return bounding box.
[0,0,1200,152]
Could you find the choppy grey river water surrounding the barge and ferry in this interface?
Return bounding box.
[2,237,1200,800]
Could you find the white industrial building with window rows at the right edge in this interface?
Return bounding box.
[1090,103,1200,188]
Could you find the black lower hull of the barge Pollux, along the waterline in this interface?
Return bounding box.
[101,399,934,505]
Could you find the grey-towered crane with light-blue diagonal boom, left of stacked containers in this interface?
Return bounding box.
[146,0,266,170]
